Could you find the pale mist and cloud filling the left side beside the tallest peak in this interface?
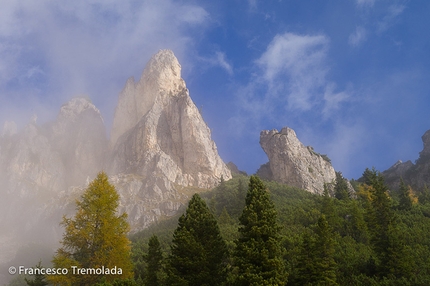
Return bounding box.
[0,0,212,285]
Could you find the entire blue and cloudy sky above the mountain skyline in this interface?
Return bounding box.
[0,0,430,179]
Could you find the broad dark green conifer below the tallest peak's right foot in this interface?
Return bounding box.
[167,194,228,286]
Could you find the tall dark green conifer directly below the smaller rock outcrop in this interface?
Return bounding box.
[234,176,287,285]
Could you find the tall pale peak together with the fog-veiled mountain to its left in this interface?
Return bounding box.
[0,50,231,284]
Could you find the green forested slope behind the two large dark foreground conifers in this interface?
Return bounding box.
[132,169,430,285]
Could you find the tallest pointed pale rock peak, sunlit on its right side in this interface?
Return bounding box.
[109,50,231,228]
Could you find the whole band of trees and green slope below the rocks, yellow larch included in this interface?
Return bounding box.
[16,169,430,285]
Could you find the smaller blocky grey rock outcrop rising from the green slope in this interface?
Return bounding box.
[257,127,336,194]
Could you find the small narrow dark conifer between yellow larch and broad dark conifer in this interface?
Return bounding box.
[145,235,163,286]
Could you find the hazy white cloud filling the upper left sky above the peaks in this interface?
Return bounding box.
[0,0,209,127]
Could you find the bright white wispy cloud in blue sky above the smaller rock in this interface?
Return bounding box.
[257,33,329,110]
